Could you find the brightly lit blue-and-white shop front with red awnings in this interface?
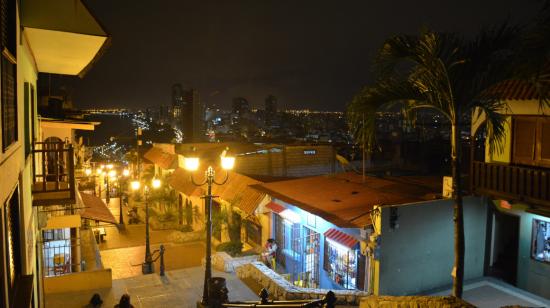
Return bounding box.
[267,202,365,290]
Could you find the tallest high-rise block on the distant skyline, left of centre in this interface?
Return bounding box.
[172,83,205,142]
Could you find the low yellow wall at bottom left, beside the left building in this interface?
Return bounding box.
[44,268,113,294]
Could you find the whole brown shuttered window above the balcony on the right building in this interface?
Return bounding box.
[512,116,550,167]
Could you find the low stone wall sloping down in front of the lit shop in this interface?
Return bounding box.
[235,261,368,305]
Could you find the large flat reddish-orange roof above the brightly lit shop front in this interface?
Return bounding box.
[251,172,441,228]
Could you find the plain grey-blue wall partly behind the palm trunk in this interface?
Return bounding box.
[379,197,487,295]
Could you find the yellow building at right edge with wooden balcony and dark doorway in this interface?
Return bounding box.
[470,81,550,298]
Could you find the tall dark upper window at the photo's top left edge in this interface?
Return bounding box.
[0,0,17,151]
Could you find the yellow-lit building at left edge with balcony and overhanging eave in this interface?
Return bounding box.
[0,0,109,307]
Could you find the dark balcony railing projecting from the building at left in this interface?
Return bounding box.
[32,142,76,206]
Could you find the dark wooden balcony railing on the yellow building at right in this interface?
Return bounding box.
[470,161,550,207]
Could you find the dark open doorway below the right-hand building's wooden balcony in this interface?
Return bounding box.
[489,209,519,286]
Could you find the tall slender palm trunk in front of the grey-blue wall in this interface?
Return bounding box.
[451,123,464,297]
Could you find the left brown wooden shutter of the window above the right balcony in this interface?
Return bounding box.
[512,118,537,165]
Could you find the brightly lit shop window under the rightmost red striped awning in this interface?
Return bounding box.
[324,239,357,289]
